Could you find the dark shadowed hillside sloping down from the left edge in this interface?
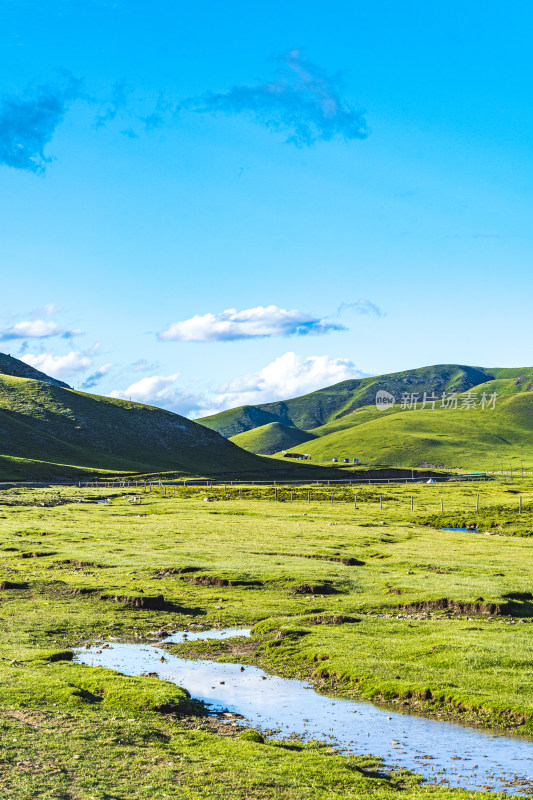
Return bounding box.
[0,356,298,480]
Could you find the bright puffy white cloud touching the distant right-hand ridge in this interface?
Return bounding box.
[197,352,364,416]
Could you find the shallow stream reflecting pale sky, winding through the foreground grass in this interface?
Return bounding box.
[76,628,533,794]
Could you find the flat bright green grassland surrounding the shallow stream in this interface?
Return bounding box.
[0,480,533,800]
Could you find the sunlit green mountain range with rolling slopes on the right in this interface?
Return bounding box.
[197,364,533,469]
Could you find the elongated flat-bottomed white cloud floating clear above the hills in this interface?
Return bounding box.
[158,305,345,342]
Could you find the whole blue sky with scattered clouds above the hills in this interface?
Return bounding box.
[0,0,533,417]
